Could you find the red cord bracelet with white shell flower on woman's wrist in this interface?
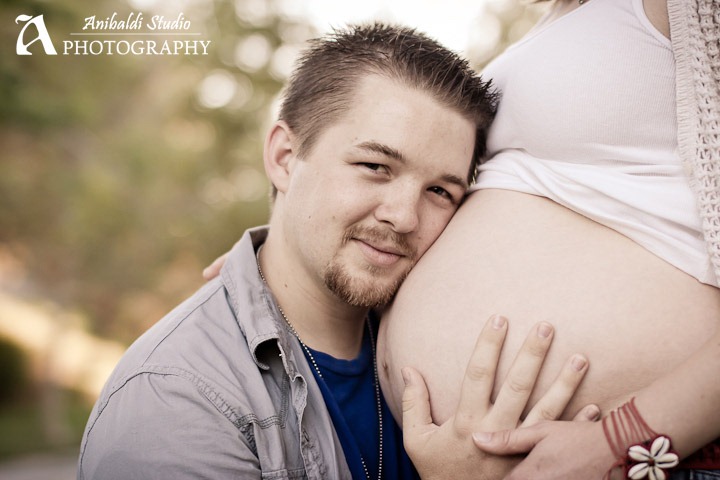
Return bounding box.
[602,397,680,480]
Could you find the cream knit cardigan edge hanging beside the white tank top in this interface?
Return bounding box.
[668,0,720,280]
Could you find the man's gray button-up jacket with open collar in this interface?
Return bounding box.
[77,227,351,480]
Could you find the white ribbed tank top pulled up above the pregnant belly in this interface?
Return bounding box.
[472,0,718,286]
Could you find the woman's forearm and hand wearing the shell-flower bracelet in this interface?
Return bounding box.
[475,324,720,480]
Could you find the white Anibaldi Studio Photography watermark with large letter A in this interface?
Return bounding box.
[15,12,211,56]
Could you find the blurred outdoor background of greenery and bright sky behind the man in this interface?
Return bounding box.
[0,0,541,480]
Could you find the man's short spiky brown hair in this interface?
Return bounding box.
[280,23,496,181]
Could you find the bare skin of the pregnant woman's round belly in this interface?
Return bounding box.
[378,190,720,423]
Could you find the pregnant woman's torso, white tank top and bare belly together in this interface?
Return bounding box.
[380,0,720,421]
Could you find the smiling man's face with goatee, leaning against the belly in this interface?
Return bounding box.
[284,75,475,307]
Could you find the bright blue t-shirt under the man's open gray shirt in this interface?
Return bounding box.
[305,318,419,480]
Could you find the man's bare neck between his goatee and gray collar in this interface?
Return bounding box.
[258,236,368,359]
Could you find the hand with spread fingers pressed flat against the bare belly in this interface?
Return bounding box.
[402,316,599,479]
